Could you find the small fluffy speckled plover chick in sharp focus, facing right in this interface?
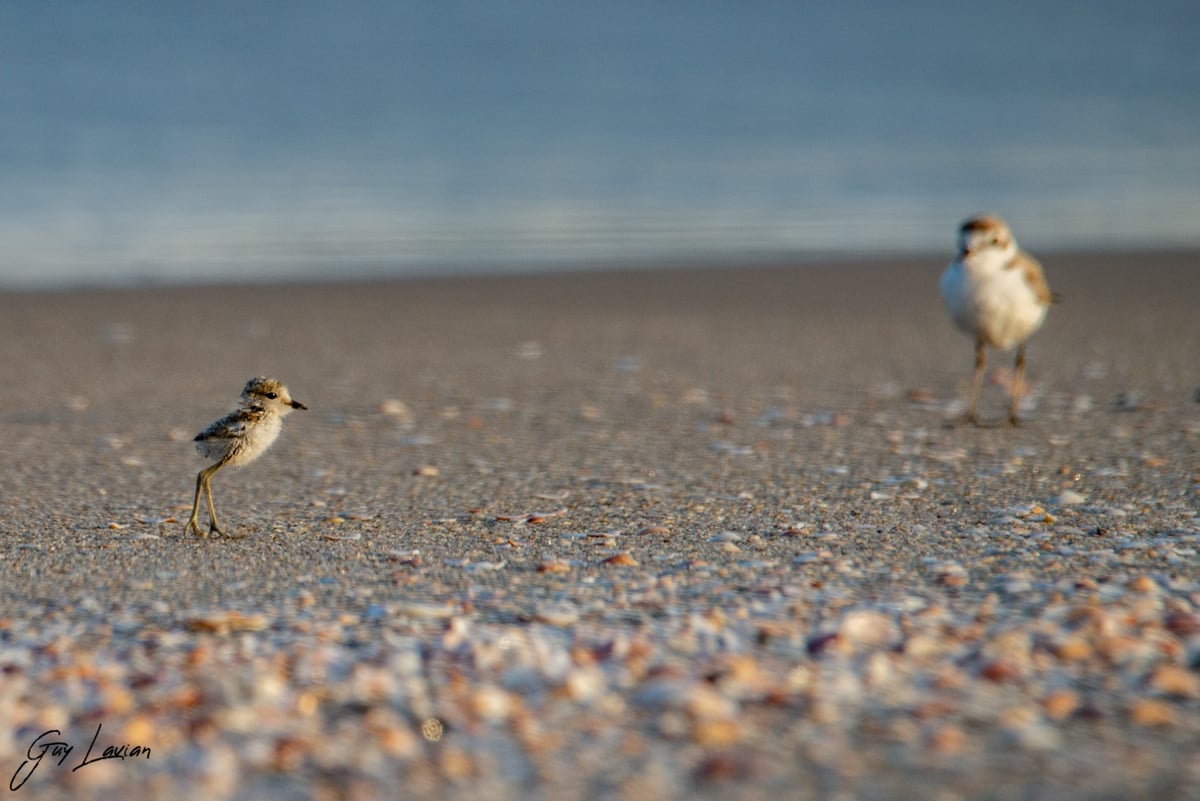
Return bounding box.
[184,377,308,537]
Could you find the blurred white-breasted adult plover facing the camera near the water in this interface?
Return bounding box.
[941,215,1056,426]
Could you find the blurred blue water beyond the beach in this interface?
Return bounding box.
[0,0,1200,285]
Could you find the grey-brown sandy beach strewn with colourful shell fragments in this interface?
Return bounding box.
[0,252,1200,801]
